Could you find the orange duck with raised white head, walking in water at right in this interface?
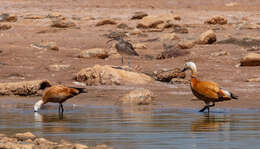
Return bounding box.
[182,62,238,112]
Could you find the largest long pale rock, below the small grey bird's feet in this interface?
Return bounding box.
[75,65,154,85]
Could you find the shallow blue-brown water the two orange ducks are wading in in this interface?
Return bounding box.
[0,100,260,149]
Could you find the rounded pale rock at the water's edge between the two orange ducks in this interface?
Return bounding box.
[119,88,154,105]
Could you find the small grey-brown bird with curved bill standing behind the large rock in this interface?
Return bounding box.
[107,36,139,64]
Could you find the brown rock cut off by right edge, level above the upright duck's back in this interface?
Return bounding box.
[240,53,260,66]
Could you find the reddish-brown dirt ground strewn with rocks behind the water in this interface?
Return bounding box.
[0,0,260,108]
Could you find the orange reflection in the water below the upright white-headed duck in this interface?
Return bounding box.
[191,114,230,132]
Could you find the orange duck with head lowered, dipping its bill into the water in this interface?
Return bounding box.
[34,85,86,113]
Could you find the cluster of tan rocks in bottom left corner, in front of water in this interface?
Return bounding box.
[0,132,113,149]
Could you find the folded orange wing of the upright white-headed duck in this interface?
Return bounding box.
[192,81,220,99]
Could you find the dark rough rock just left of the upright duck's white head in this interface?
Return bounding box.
[153,68,185,82]
